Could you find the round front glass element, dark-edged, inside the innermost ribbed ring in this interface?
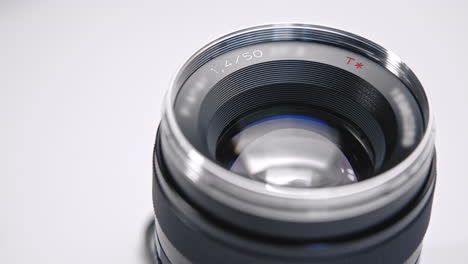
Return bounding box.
[216,105,377,188]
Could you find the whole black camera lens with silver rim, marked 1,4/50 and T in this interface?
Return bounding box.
[153,24,435,264]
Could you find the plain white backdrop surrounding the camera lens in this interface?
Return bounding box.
[0,0,468,264]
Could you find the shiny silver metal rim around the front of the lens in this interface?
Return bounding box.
[161,24,434,222]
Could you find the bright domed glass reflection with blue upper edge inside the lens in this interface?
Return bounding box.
[219,115,358,188]
